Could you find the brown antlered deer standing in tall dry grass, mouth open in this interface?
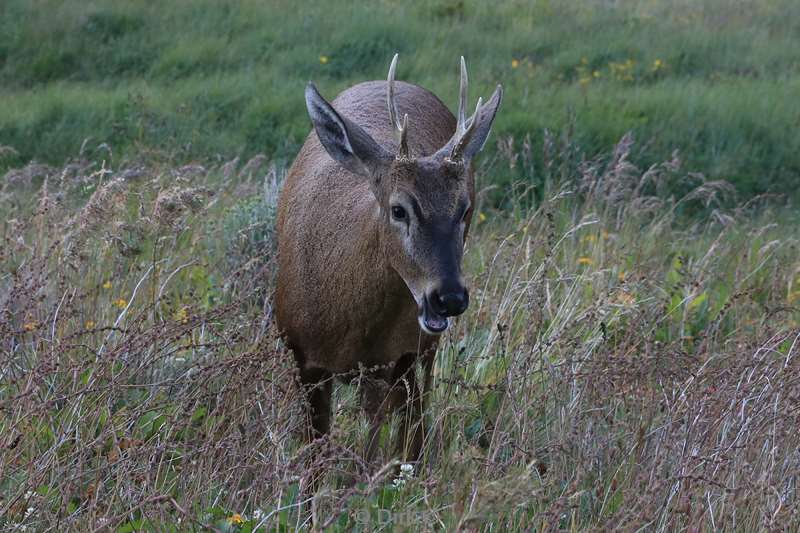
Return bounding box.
[274,55,503,470]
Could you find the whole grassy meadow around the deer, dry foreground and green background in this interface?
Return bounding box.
[0,0,800,532]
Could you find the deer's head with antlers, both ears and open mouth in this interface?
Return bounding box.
[305,55,503,334]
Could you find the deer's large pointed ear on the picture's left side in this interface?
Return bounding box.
[306,82,392,177]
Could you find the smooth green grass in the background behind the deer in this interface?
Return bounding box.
[0,0,800,195]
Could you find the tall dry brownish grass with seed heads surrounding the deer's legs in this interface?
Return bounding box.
[0,136,800,531]
